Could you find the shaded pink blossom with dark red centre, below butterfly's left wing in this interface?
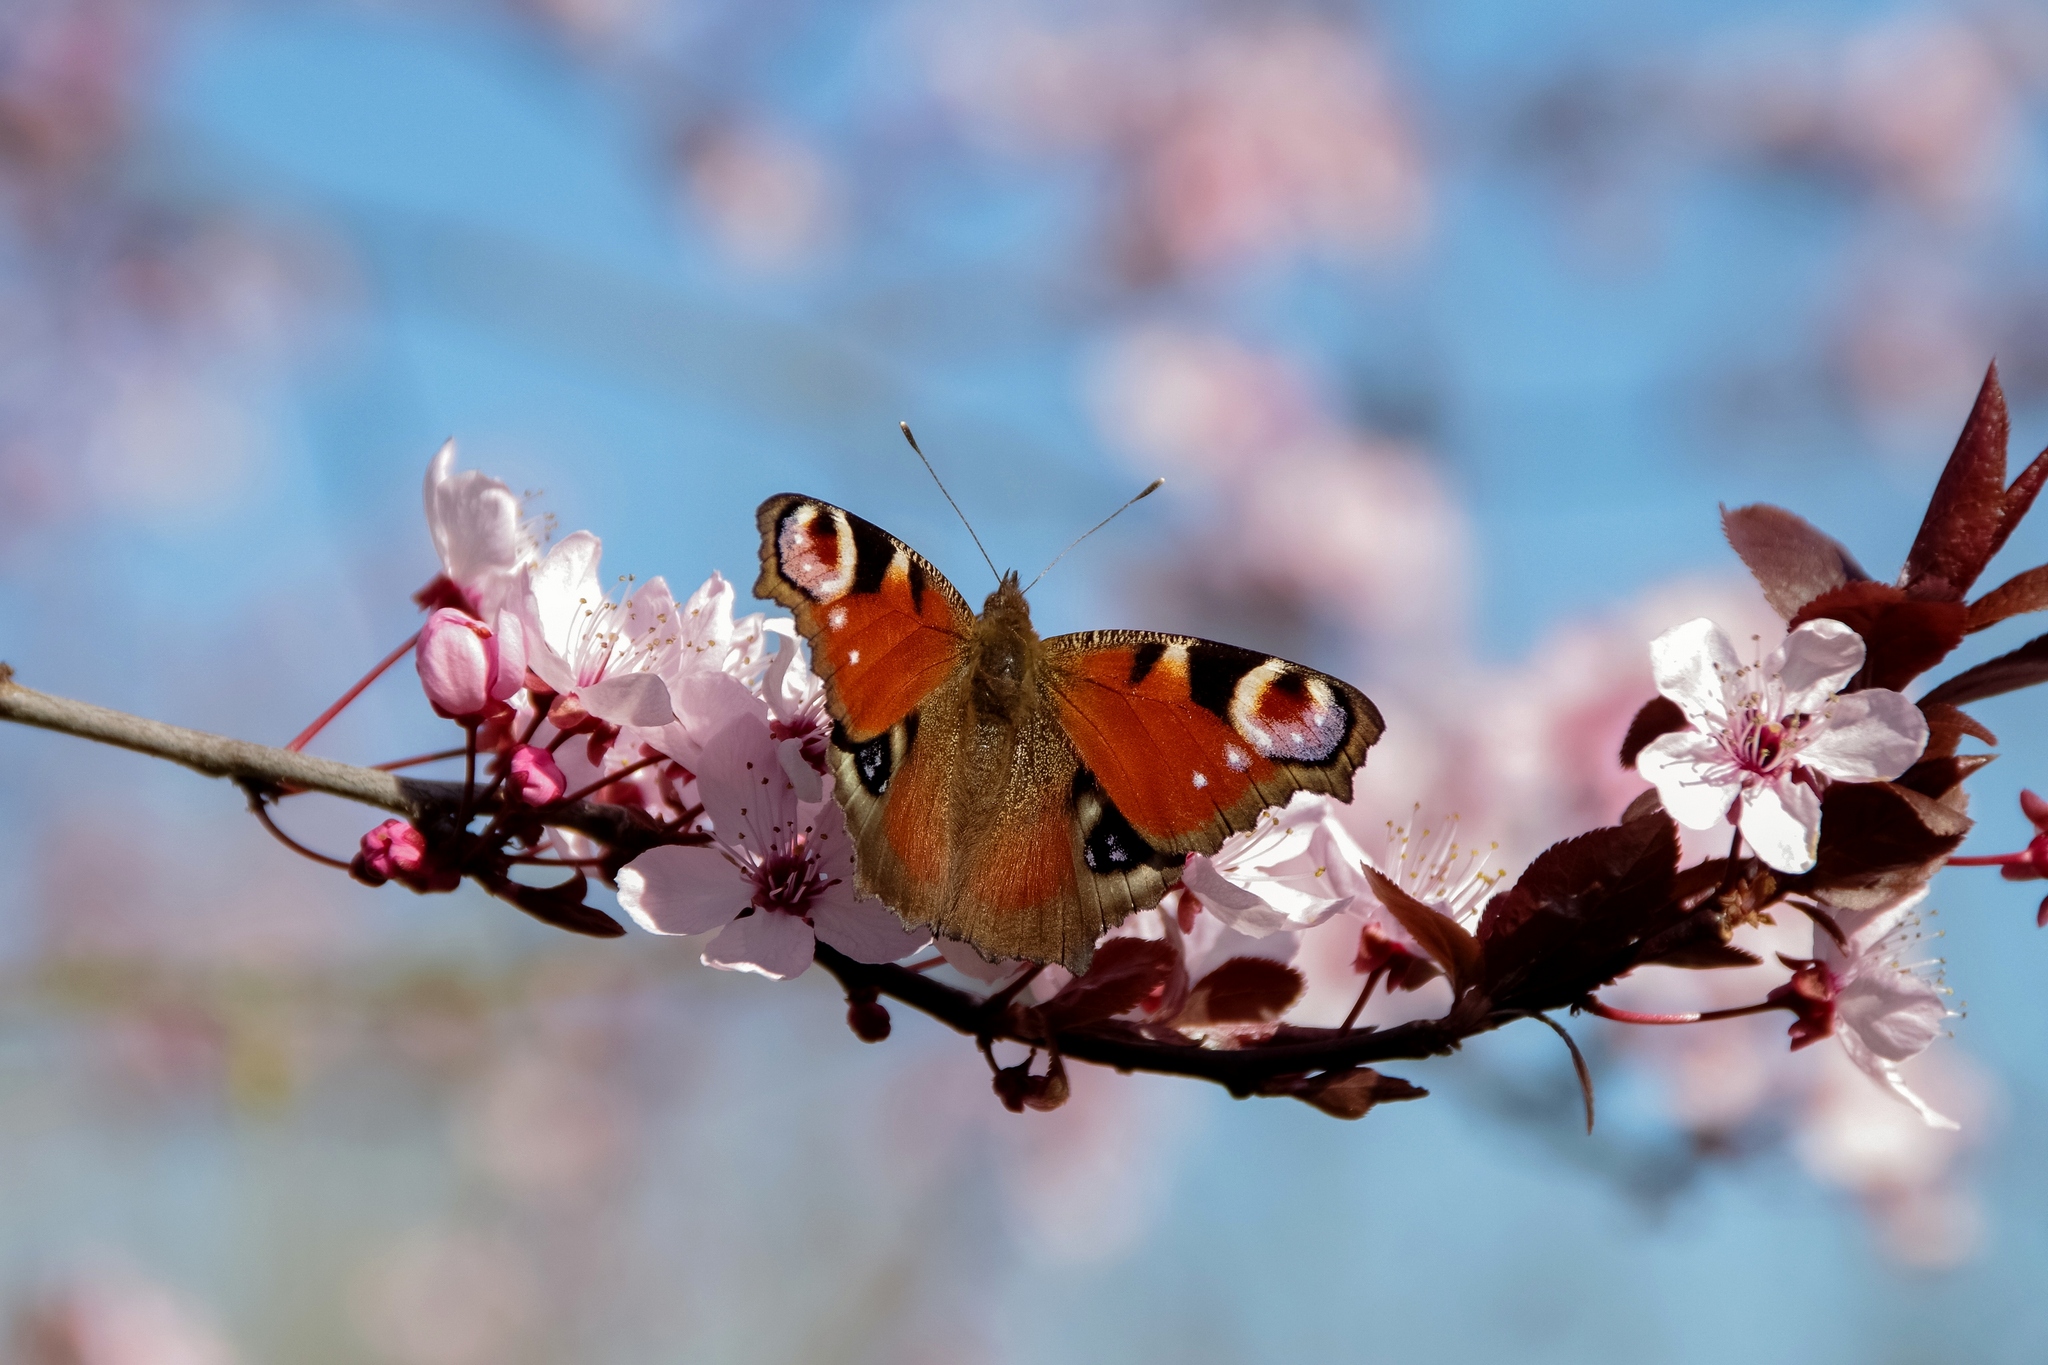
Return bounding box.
[618,716,932,980]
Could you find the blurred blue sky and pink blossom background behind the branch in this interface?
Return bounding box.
[0,0,2048,1365]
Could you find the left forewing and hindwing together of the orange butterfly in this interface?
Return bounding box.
[754,493,975,945]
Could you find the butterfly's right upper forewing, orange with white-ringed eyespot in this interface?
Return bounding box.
[1044,630,1386,853]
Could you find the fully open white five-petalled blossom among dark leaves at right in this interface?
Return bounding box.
[1636,616,1927,872]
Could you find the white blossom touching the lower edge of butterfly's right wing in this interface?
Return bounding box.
[1182,792,1366,937]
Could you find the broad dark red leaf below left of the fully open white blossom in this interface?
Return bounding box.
[1479,810,1688,1009]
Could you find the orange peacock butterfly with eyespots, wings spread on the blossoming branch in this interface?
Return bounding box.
[754,493,1384,974]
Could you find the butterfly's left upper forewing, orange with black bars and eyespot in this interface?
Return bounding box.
[754,493,975,745]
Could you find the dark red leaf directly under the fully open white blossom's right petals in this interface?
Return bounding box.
[1784,782,1970,911]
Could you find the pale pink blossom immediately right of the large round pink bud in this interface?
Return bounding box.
[520,530,680,729]
